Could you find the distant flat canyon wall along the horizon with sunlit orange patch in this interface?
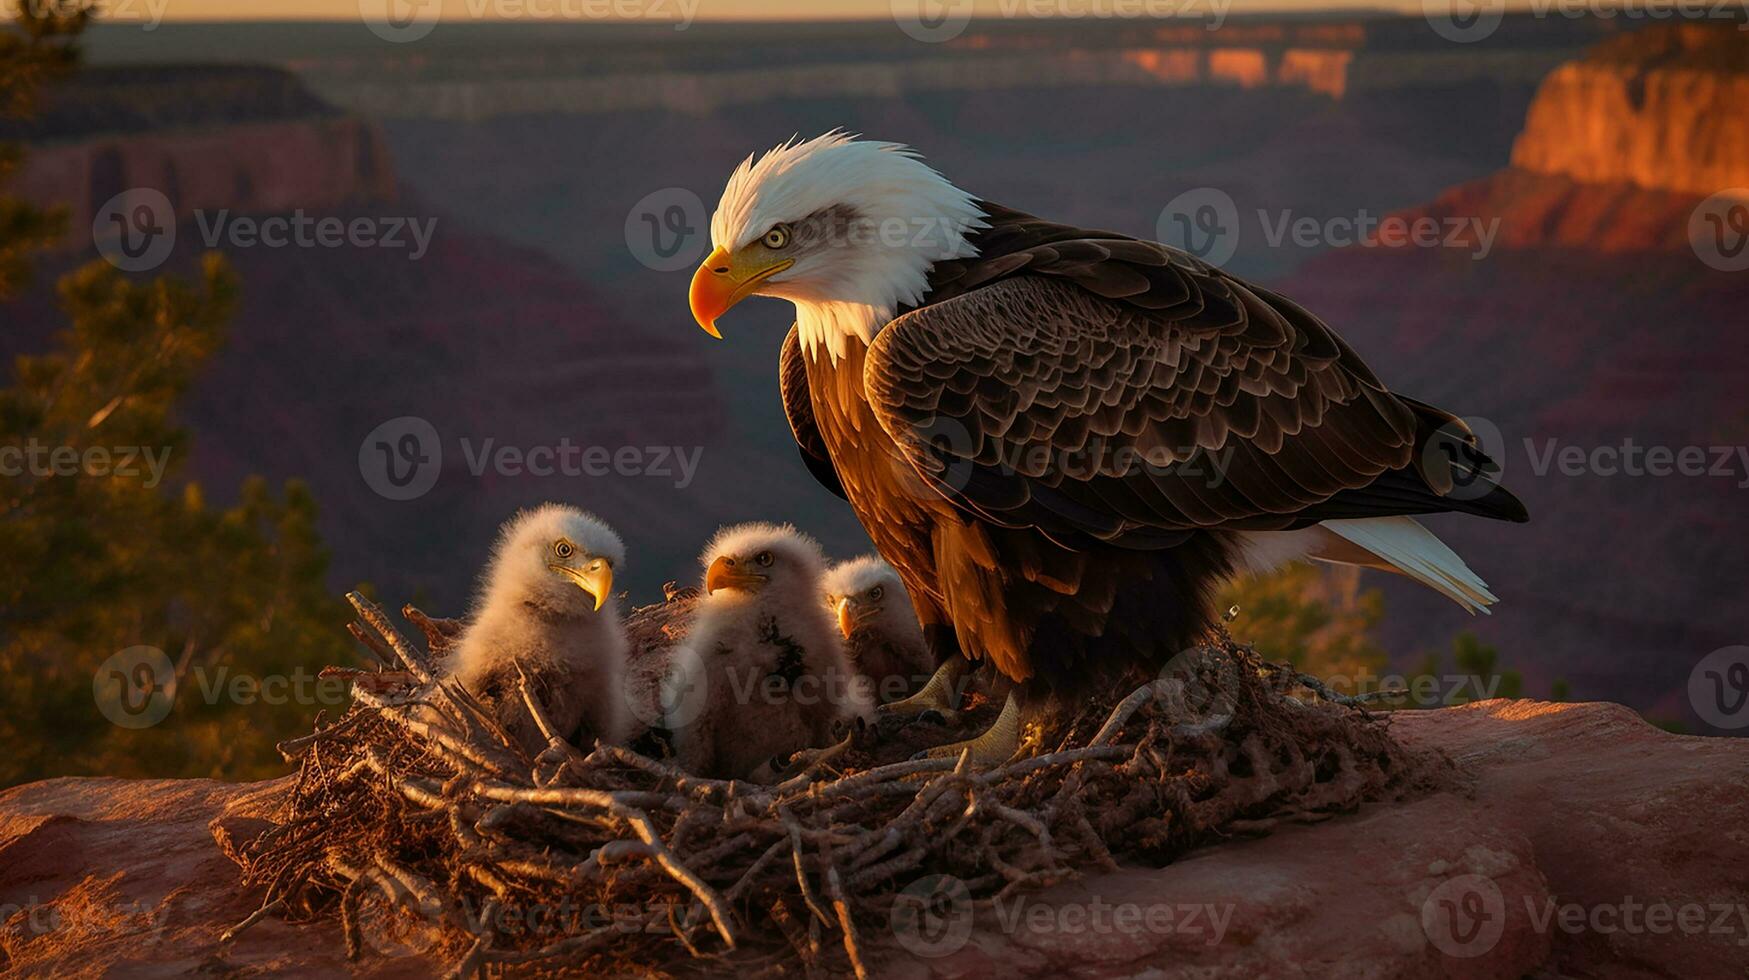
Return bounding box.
[299,18,1607,121]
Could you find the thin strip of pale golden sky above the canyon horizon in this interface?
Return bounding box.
[164,0,1420,21]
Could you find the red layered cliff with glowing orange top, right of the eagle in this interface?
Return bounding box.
[1280,25,1749,725]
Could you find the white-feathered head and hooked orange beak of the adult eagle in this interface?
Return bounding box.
[691,130,985,359]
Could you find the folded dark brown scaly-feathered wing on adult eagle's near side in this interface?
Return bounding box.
[864,248,1523,548]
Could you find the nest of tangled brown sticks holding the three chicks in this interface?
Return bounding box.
[233,595,1450,977]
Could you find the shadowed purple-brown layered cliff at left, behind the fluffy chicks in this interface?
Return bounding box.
[0,67,734,604]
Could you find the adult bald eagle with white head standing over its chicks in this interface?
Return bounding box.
[691,131,1527,763]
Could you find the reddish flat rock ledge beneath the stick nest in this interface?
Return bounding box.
[0,700,1749,978]
